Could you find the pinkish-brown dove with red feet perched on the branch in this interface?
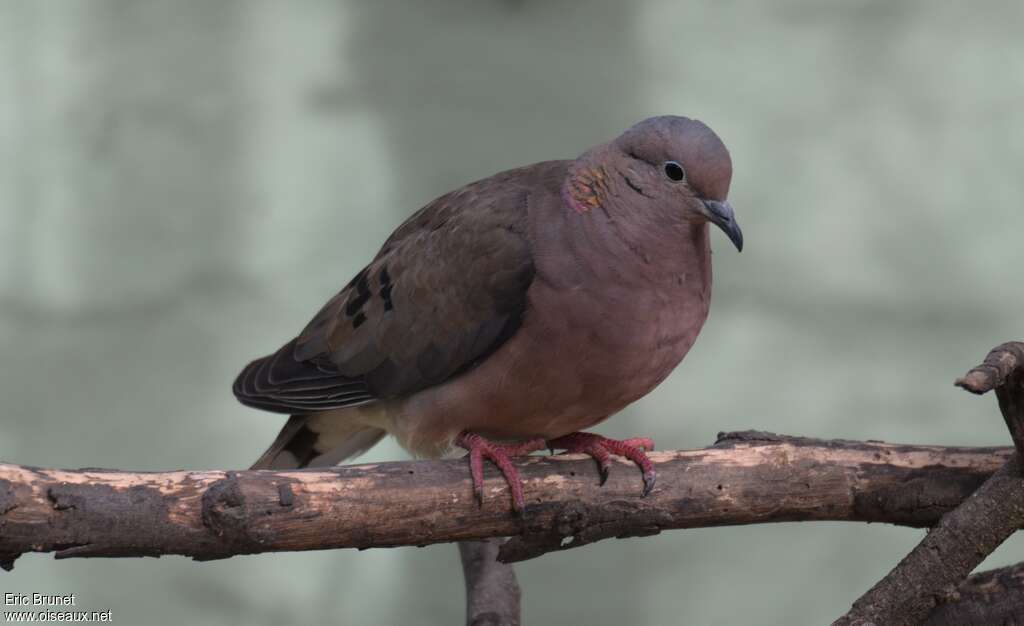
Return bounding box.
[233,116,743,512]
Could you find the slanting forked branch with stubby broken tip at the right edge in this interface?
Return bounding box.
[834,342,1024,626]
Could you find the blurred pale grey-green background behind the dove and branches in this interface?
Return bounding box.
[0,0,1024,626]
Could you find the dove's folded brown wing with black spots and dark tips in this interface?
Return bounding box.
[234,162,564,413]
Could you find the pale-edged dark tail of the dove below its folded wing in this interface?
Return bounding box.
[251,411,387,469]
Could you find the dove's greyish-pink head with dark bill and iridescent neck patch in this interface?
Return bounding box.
[565,116,743,250]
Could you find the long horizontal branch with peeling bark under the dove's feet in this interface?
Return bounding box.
[0,432,1012,568]
